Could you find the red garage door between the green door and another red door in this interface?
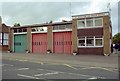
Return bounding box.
[32,33,47,53]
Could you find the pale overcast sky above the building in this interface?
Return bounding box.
[0,0,119,35]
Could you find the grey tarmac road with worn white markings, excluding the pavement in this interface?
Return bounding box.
[2,60,118,80]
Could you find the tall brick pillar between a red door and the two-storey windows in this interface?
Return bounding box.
[72,20,77,53]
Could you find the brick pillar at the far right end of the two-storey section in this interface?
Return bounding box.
[103,16,111,54]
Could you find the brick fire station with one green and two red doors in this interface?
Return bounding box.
[9,12,112,55]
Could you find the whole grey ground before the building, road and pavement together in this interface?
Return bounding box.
[1,53,119,81]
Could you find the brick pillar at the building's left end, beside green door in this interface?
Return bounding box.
[8,28,14,51]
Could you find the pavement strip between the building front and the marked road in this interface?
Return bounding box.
[2,53,119,69]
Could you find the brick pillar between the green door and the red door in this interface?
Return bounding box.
[27,28,32,52]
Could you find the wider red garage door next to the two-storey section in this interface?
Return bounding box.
[53,32,72,54]
